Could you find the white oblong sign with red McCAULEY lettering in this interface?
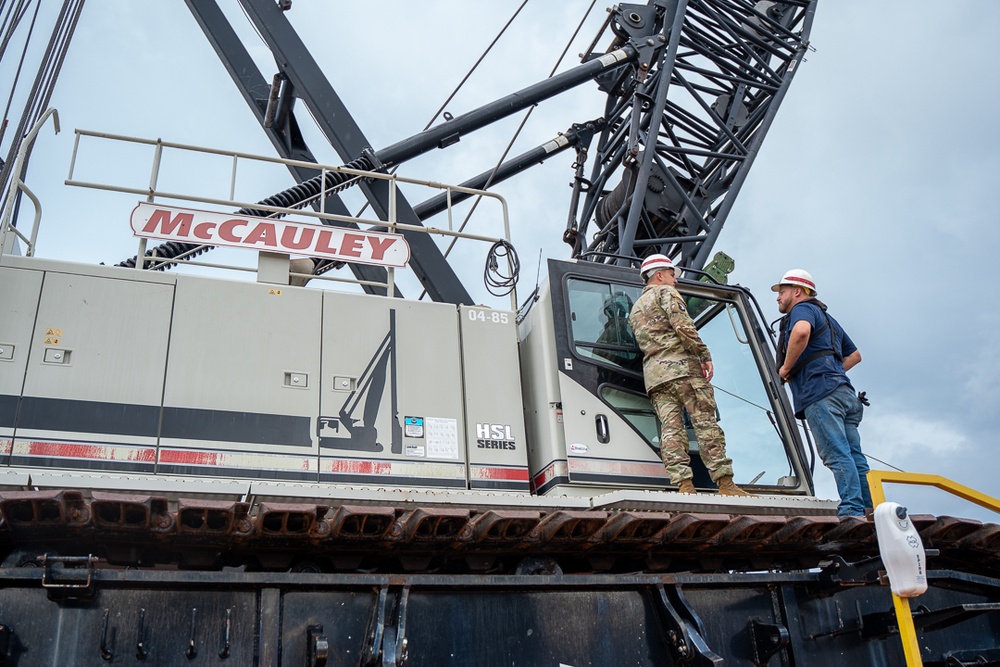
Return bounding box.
[130,202,410,268]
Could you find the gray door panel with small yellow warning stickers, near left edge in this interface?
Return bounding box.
[14,271,173,454]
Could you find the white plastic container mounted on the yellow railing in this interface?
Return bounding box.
[875,503,927,598]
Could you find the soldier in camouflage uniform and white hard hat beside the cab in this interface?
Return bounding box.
[629,255,751,496]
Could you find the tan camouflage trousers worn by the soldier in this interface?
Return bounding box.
[649,377,733,485]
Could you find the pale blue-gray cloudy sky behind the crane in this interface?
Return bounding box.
[0,0,1000,521]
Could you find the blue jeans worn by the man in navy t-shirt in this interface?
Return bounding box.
[803,384,872,517]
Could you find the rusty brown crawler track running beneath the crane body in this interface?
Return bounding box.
[0,490,1000,576]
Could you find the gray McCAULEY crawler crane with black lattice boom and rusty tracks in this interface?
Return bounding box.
[0,0,1000,667]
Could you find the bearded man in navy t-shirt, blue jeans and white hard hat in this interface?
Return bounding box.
[771,269,872,517]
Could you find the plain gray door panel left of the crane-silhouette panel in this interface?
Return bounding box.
[161,276,322,460]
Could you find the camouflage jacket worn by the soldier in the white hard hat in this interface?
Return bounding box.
[628,285,712,391]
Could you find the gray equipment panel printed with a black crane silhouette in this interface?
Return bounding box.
[319,292,467,488]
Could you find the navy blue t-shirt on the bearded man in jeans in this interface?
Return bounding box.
[785,301,858,419]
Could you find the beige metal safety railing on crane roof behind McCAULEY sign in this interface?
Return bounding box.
[40,130,517,310]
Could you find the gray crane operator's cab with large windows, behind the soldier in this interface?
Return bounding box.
[522,260,808,493]
